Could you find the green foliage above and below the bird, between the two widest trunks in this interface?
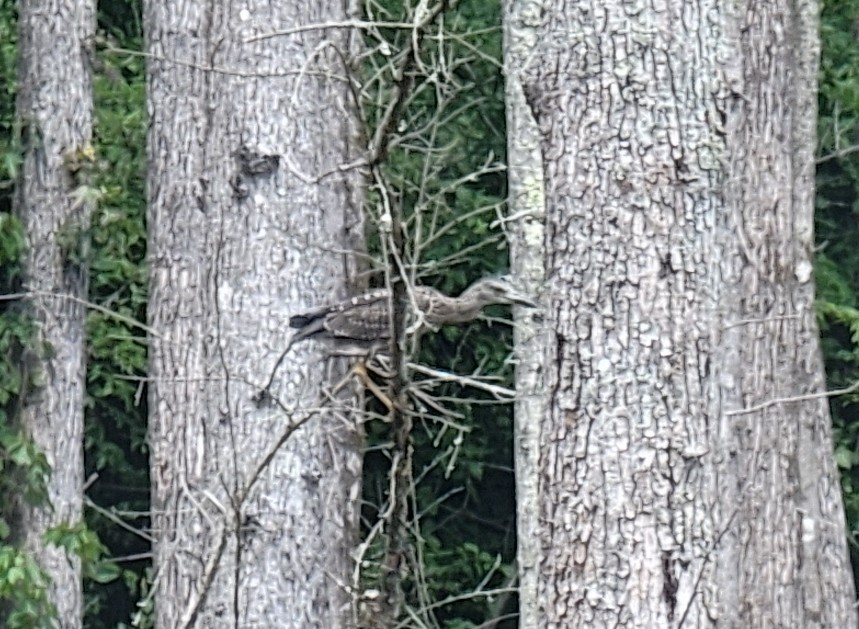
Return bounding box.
[365,0,515,627]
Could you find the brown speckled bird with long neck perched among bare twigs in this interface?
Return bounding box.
[256,276,537,405]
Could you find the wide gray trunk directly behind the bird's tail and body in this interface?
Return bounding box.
[145,0,362,629]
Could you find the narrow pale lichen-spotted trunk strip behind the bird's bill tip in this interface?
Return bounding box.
[504,1,547,627]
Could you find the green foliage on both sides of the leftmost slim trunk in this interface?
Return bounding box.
[0,0,149,628]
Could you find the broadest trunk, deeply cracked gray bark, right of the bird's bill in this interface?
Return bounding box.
[520,0,856,628]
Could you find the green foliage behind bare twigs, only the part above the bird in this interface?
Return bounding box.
[365,0,507,280]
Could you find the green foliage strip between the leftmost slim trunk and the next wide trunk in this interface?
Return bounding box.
[85,17,149,629]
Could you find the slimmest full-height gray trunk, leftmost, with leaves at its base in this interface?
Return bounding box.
[15,0,95,627]
